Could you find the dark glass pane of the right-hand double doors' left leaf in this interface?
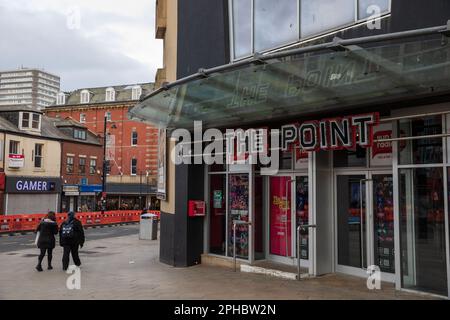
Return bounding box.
[337,176,366,268]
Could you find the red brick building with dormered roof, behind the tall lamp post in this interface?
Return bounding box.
[45,83,158,210]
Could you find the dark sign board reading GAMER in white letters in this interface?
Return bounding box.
[5,176,61,193]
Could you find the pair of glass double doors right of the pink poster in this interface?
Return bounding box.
[335,172,395,281]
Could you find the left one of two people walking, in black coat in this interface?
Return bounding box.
[36,211,58,272]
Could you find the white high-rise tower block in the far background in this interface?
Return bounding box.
[0,68,60,110]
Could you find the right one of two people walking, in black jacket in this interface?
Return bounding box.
[59,211,85,271]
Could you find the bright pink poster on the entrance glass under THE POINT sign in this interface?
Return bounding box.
[270,177,291,256]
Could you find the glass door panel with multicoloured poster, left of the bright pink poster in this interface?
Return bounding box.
[228,174,250,259]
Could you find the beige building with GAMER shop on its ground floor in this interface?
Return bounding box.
[0,107,61,214]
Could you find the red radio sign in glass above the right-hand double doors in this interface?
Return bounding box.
[370,123,392,167]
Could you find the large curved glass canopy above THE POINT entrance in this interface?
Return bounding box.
[129,24,450,130]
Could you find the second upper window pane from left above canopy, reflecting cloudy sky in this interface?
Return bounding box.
[253,0,299,52]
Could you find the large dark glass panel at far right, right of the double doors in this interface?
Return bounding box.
[399,168,448,295]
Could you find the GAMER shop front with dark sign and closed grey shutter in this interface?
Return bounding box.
[4,176,61,215]
